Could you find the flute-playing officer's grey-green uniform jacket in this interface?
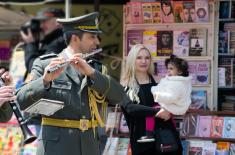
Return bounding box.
[17,55,125,155]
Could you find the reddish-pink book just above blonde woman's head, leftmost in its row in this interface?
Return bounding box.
[126,30,143,55]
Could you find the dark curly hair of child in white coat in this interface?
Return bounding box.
[165,54,189,77]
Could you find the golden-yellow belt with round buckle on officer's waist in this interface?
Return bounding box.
[42,117,98,131]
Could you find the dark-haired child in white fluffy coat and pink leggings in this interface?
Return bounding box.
[138,55,192,142]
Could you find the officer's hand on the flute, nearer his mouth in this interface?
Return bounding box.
[71,53,95,76]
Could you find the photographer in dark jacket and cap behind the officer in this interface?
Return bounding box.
[21,7,66,135]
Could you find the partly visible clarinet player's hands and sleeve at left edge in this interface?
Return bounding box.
[0,68,16,122]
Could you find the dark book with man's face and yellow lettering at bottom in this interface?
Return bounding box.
[157,31,173,56]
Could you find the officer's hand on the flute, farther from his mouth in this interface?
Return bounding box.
[43,58,65,86]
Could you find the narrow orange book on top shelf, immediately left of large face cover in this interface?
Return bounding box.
[151,2,162,23]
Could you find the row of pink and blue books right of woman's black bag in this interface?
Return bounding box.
[180,110,235,142]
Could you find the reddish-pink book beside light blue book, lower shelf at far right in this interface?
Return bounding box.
[210,116,224,138]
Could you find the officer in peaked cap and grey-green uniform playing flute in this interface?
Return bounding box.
[17,12,125,155]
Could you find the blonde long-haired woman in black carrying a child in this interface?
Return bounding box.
[121,44,182,155]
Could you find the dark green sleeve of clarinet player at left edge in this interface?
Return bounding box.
[0,103,13,122]
